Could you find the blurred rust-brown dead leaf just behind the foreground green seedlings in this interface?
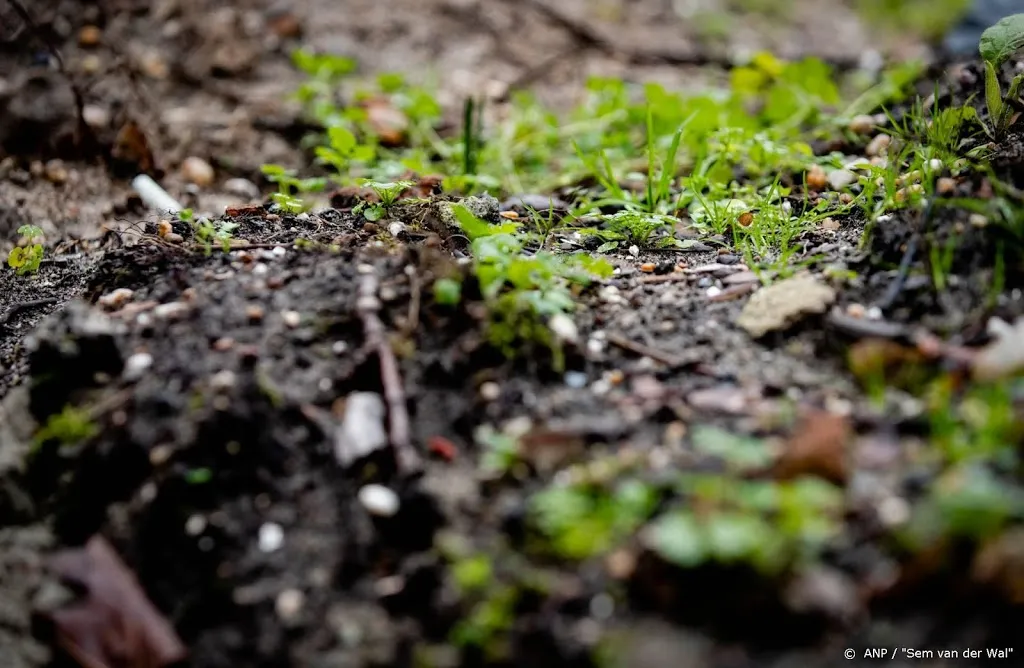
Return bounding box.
[775,411,852,484]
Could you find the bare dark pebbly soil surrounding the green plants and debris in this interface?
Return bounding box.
[0,0,1024,668]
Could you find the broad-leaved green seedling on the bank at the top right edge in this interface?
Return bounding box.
[978,13,1024,140]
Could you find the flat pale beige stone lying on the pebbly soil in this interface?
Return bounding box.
[736,274,836,338]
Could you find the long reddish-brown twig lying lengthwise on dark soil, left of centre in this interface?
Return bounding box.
[355,273,421,474]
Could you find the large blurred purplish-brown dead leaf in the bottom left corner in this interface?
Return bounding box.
[49,535,187,668]
